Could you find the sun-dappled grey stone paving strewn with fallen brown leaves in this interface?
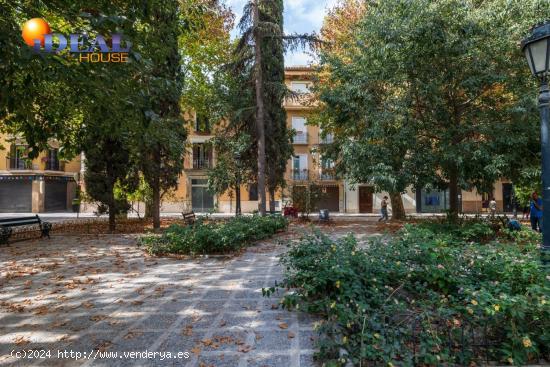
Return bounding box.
[0,223,388,367]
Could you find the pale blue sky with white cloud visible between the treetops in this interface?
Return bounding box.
[225,0,338,66]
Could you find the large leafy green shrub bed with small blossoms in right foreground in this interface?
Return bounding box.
[270,224,550,366]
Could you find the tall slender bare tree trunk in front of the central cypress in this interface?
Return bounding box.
[254,0,266,216]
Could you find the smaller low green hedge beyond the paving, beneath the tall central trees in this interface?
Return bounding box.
[140,215,288,255]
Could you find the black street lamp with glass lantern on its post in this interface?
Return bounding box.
[521,20,550,265]
